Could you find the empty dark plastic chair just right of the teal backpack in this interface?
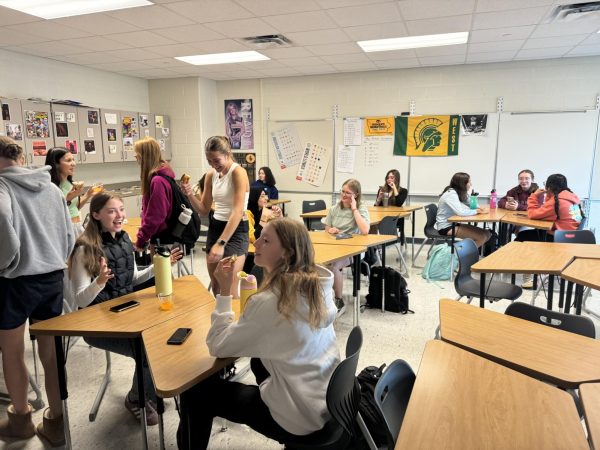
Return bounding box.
[454,239,523,303]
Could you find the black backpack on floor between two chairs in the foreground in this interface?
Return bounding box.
[356,364,388,448]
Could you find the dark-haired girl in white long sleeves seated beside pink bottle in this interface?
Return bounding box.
[435,172,492,248]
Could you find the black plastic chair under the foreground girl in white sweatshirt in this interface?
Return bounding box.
[285,327,363,450]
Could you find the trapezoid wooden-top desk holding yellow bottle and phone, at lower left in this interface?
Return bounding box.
[30,276,214,449]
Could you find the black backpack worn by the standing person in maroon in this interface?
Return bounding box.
[152,173,200,254]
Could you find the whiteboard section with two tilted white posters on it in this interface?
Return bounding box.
[267,119,335,194]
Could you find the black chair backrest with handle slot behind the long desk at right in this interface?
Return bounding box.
[504,302,596,339]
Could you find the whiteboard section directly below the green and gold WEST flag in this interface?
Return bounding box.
[406,113,496,196]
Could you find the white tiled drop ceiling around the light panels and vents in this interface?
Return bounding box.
[0,0,600,80]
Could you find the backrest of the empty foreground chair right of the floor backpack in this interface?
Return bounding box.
[374,359,416,449]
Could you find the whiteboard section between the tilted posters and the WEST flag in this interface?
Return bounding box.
[335,120,408,194]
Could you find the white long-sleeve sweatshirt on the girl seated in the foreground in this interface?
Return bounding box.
[206,267,340,435]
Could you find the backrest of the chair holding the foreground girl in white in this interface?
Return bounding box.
[326,327,362,436]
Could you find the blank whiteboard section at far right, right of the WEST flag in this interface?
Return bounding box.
[496,110,598,198]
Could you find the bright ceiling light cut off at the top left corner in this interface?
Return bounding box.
[0,0,153,19]
